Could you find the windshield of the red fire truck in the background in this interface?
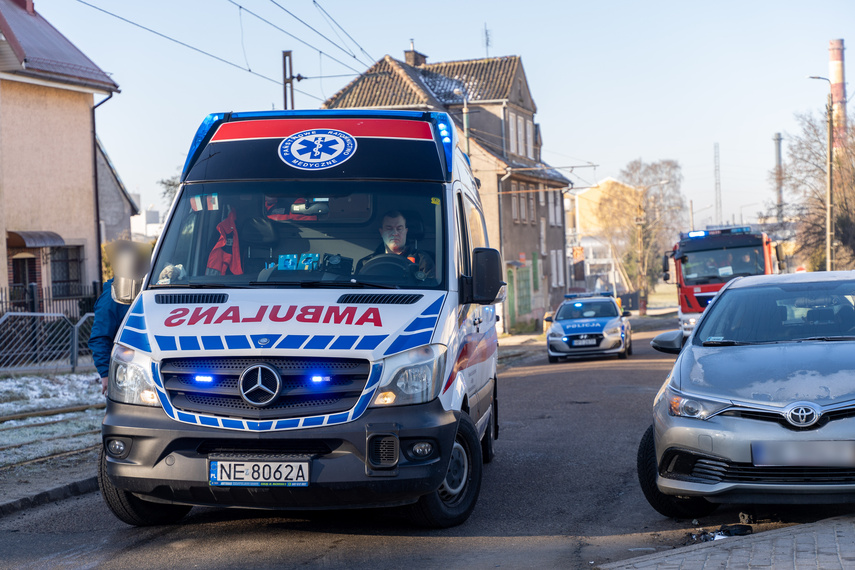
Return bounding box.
[681,246,764,285]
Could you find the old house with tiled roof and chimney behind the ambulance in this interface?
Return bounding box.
[323,49,570,331]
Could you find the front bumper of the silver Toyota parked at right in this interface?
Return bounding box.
[654,410,855,504]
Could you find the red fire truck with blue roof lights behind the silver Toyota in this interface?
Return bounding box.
[662,227,784,336]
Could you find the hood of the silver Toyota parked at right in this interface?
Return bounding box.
[678,342,855,406]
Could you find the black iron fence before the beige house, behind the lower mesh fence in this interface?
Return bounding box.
[0,282,100,321]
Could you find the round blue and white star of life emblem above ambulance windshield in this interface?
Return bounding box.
[279,129,356,170]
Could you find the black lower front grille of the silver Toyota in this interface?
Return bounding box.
[662,451,855,484]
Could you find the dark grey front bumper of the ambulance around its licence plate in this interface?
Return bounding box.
[102,400,458,509]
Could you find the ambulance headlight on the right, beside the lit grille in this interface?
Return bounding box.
[371,344,446,407]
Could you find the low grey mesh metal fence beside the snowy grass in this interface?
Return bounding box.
[0,311,95,374]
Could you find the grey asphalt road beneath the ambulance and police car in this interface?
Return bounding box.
[0,332,852,569]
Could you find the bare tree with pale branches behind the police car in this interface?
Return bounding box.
[598,159,686,311]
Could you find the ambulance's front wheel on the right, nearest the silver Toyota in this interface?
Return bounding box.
[410,413,483,528]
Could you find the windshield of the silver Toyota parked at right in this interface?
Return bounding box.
[694,281,855,344]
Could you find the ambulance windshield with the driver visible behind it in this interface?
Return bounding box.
[150,181,446,289]
